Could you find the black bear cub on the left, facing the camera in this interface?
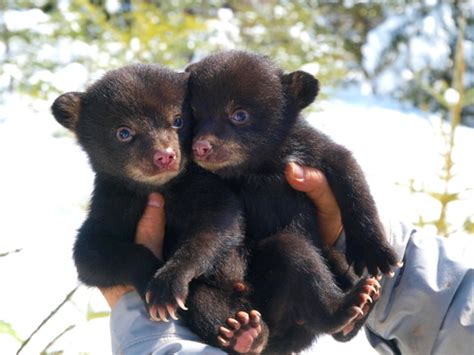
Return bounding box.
[52,65,268,352]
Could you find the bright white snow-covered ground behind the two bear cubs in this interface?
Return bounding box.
[0,90,474,354]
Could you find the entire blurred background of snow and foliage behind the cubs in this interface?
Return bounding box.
[0,0,474,354]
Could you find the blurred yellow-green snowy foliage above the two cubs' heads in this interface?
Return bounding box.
[0,0,351,97]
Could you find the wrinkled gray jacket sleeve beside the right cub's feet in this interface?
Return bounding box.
[360,224,474,355]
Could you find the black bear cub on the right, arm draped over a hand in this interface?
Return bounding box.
[187,51,397,353]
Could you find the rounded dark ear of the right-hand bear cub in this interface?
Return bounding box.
[281,70,319,110]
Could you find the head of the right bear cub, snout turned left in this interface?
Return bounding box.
[186,51,319,176]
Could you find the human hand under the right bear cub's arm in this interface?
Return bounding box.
[285,162,342,246]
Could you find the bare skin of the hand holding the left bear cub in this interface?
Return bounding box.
[100,193,166,309]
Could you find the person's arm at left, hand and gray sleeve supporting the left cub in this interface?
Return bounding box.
[101,194,224,355]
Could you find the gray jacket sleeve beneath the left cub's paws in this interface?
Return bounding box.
[110,292,225,355]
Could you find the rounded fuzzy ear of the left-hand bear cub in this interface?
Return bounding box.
[51,92,83,131]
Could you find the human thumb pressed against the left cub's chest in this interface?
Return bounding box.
[135,193,166,260]
